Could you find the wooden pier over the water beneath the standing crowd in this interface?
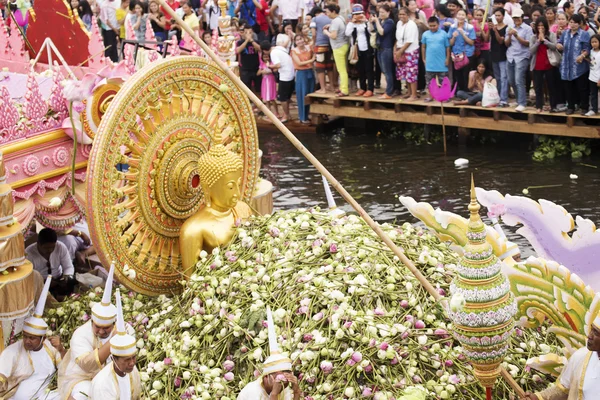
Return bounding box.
[306,93,600,139]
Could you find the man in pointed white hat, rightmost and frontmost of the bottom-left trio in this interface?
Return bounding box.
[90,290,142,400]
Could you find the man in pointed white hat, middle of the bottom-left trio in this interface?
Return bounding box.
[58,264,117,400]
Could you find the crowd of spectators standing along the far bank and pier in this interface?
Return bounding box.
[82,0,600,124]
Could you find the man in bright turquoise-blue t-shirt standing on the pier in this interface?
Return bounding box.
[421,16,450,101]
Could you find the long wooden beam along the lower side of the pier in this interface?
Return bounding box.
[311,103,600,139]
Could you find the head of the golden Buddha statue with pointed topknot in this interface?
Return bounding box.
[198,132,243,211]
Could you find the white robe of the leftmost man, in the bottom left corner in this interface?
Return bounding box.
[0,340,61,400]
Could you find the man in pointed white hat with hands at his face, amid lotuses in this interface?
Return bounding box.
[237,307,300,400]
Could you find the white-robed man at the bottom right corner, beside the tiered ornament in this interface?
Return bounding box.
[525,314,600,400]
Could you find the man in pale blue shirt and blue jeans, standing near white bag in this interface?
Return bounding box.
[504,9,533,112]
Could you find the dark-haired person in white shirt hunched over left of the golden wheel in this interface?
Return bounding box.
[25,228,75,297]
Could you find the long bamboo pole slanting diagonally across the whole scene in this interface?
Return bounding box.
[158,0,523,394]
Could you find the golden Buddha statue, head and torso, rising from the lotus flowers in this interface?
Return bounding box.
[179,133,252,277]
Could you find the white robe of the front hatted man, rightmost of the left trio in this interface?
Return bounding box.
[90,362,142,400]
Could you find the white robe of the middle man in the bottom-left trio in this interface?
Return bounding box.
[58,320,109,400]
